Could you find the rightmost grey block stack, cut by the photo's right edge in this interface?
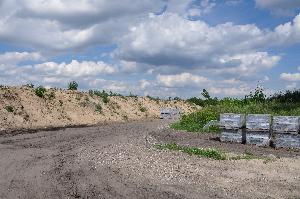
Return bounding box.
[273,116,300,148]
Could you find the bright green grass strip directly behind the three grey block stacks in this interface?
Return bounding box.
[171,100,300,132]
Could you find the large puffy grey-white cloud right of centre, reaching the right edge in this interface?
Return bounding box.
[115,13,300,74]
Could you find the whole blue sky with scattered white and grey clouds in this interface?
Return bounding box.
[0,0,300,97]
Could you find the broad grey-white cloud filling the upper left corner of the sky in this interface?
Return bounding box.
[0,0,165,51]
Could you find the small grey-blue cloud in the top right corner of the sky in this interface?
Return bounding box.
[255,0,300,15]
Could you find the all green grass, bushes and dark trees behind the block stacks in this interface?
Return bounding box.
[171,87,300,132]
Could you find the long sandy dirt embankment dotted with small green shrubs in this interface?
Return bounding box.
[0,87,196,130]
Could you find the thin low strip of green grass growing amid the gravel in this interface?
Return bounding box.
[154,143,262,160]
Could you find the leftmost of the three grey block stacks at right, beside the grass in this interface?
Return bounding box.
[219,113,245,143]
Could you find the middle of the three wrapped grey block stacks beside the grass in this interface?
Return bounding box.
[246,114,271,146]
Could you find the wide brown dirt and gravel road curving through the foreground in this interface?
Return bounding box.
[0,121,300,199]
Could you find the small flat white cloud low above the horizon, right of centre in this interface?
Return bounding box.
[157,73,209,87]
